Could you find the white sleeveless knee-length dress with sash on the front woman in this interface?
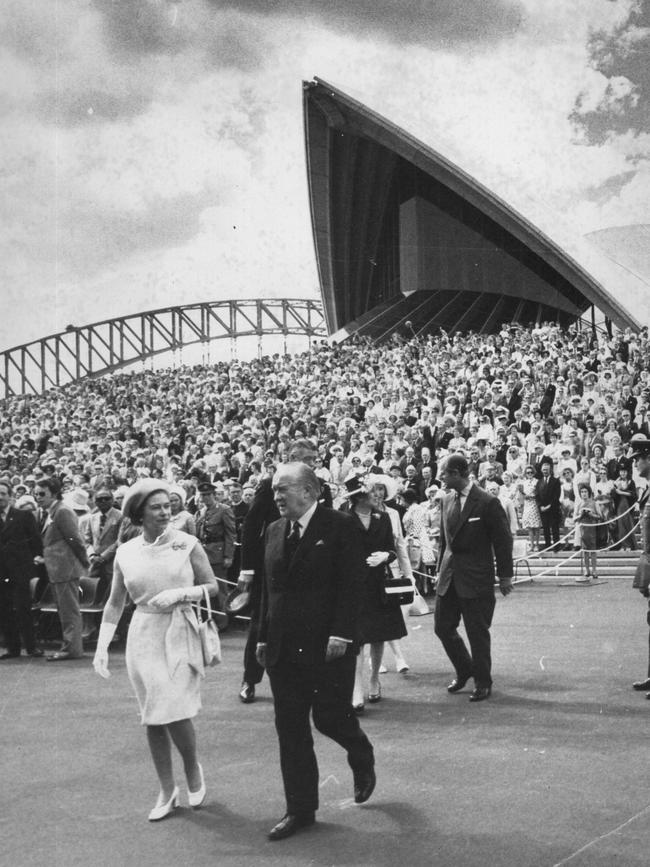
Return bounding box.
[115,528,205,725]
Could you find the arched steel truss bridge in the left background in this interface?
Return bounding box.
[0,299,327,398]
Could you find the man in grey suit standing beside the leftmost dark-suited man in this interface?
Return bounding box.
[34,478,90,662]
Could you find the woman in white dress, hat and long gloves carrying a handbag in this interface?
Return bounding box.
[93,479,217,822]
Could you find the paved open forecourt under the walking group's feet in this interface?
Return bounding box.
[0,578,650,867]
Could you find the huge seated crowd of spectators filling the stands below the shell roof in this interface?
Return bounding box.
[0,323,650,572]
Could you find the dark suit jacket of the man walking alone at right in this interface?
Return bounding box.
[436,484,513,599]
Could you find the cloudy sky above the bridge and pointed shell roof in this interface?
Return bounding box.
[0,0,650,349]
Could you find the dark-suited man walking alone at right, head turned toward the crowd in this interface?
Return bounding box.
[434,455,513,702]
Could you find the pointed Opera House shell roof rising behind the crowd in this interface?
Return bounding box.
[303,79,650,337]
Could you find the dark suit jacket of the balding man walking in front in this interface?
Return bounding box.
[259,505,365,668]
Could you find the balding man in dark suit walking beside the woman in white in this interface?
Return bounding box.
[257,463,376,840]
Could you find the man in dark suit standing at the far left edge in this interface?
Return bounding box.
[0,479,43,659]
